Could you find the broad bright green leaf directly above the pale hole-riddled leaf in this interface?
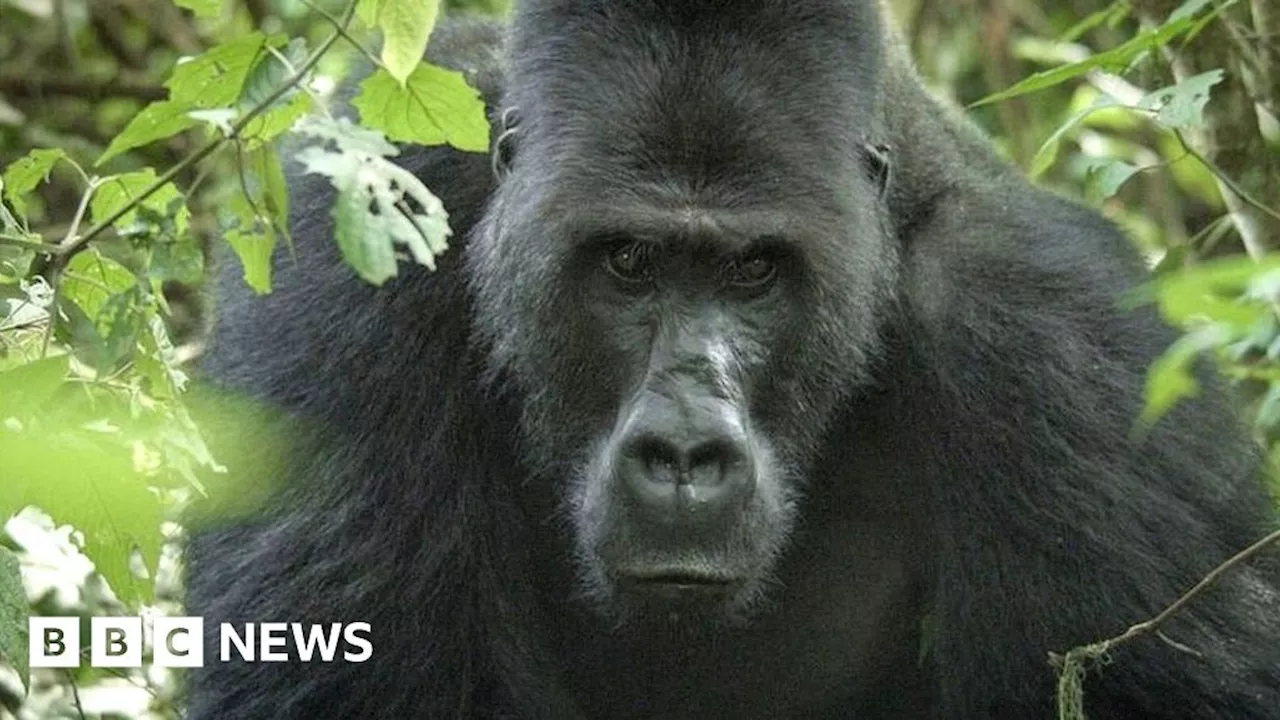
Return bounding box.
[352,63,489,152]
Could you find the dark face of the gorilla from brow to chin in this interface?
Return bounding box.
[470,147,896,621]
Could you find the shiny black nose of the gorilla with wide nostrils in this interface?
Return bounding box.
[617,393,755,524]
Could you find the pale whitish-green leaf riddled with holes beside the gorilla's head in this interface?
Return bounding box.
[297,118,451,284]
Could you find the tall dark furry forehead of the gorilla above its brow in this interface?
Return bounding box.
[507,3,879,188]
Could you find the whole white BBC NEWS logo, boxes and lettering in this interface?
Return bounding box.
[28,616,374,667]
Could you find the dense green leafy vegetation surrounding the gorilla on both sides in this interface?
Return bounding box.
[0,0,1280,717]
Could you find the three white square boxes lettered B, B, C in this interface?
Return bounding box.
[28,616,205,667]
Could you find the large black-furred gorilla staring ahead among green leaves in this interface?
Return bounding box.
[188,0,1280,720]
